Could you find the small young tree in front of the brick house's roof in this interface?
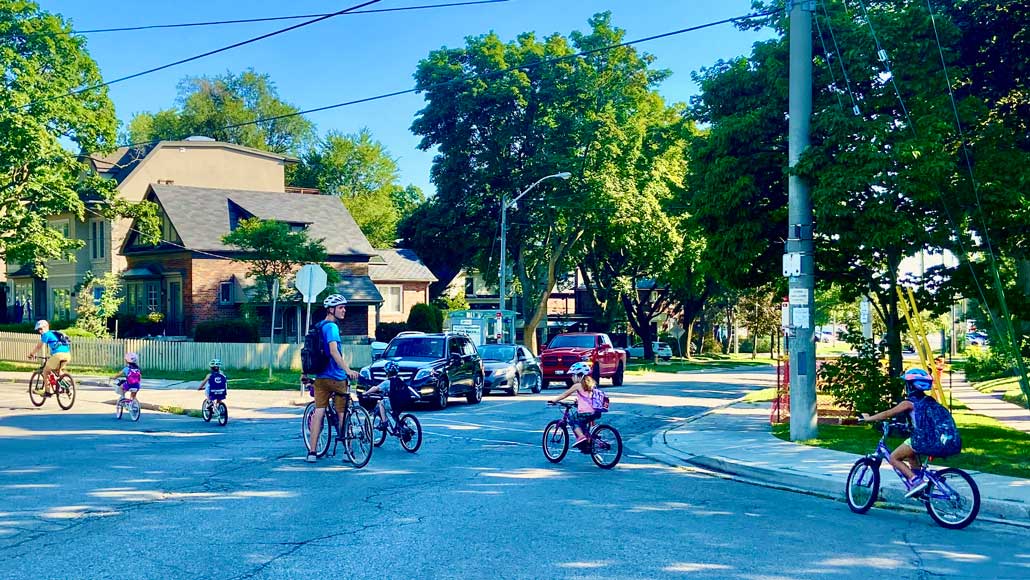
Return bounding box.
[221,217,327,298]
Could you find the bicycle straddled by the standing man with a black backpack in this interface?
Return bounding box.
[301,379,373,469]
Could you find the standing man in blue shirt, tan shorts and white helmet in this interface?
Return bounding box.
[306,294,357,464]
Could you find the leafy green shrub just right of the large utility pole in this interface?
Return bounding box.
[818,330,904,414]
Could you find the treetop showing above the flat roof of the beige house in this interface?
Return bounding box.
[127,69,315,156]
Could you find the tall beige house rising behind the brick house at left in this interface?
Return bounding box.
[6,137,297,319]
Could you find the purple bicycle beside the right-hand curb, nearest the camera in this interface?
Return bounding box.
[845,421,980,530]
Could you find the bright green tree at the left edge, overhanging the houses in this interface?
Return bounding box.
[0,0,155,277]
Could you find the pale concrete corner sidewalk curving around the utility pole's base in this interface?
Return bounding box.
[640,401,1030,526]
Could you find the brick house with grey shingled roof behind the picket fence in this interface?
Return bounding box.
[122,184,383,340]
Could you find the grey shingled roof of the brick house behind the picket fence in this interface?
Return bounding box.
[139,183,376,257]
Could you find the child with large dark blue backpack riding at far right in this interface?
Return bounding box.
[859,369,962,498]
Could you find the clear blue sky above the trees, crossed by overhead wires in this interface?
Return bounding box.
[39,0,770,194]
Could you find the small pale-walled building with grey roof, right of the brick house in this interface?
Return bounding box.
[369,249,437,323]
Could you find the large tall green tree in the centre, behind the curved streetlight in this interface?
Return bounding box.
[409,13,665,350]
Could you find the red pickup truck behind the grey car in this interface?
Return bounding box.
[540,333,626,388]
